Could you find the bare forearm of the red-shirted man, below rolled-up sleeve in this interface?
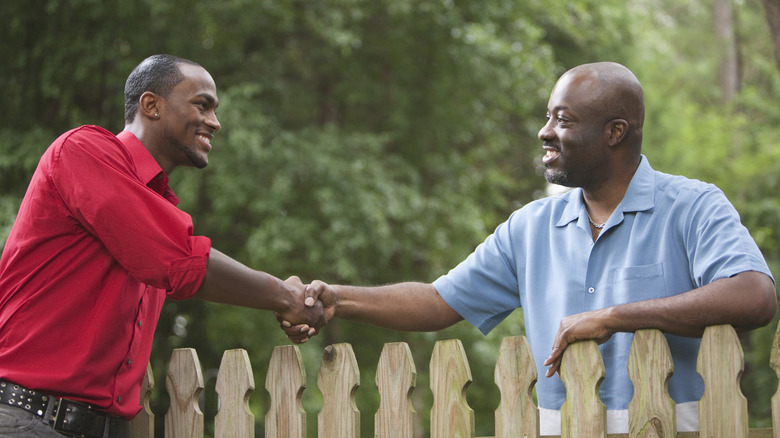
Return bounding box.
[196,248,292,312]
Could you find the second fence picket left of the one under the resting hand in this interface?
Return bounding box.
[430,339,474,438]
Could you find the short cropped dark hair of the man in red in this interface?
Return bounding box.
[125,54,200,124]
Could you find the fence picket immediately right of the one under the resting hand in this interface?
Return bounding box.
[628,330,677,438]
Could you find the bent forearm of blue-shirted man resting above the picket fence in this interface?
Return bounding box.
[605,271,777,337]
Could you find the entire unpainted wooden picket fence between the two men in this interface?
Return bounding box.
[125,325,780,438]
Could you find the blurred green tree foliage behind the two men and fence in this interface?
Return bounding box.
[0,0,780,436]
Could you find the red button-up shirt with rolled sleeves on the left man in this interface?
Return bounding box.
[0,126,211,418]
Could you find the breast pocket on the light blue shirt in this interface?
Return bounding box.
[612,263,666,304]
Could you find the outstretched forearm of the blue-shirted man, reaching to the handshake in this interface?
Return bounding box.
[332,283,463,331]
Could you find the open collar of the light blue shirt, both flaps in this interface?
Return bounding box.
[555,155,655,227]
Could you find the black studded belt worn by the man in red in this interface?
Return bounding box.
[0,380,130,438]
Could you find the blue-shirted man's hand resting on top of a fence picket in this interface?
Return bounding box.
[544,308,615,377]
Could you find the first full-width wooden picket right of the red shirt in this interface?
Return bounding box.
[165,348,203,438]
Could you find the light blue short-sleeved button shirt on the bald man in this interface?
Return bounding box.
[434,156,771,410]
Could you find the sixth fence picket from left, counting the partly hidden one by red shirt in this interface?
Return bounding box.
[374,342,417,438]
